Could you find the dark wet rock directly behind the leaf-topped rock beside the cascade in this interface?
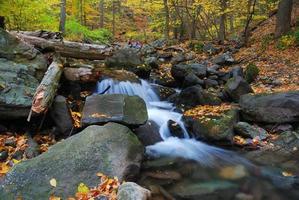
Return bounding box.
[176,85,221,108]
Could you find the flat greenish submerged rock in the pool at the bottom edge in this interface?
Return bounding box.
[170,180,238,200]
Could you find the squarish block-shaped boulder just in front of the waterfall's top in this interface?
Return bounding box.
[81,94,148,126]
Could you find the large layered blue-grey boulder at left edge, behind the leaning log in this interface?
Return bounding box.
[0,28,47,119]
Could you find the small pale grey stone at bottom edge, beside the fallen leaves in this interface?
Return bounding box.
[117,182,151,200]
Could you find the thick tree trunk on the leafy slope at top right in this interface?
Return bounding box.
[275,0,293,37]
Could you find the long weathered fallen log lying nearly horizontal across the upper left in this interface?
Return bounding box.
[12,32,113,60]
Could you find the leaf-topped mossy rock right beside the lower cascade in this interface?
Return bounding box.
[183,109,239,141]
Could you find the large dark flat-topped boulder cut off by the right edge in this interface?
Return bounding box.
[240,91,299,124]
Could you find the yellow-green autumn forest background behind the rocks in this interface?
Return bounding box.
[0,0,298,44]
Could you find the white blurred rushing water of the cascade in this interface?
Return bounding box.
[96,79,250,166]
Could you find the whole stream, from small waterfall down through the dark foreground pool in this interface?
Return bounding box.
[95,79,298,199]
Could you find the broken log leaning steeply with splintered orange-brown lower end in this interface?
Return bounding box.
[27,59,63,121]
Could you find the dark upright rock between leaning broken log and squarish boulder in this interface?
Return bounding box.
[50,95,73,135]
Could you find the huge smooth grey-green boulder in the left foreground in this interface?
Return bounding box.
[0,123,143,200]
